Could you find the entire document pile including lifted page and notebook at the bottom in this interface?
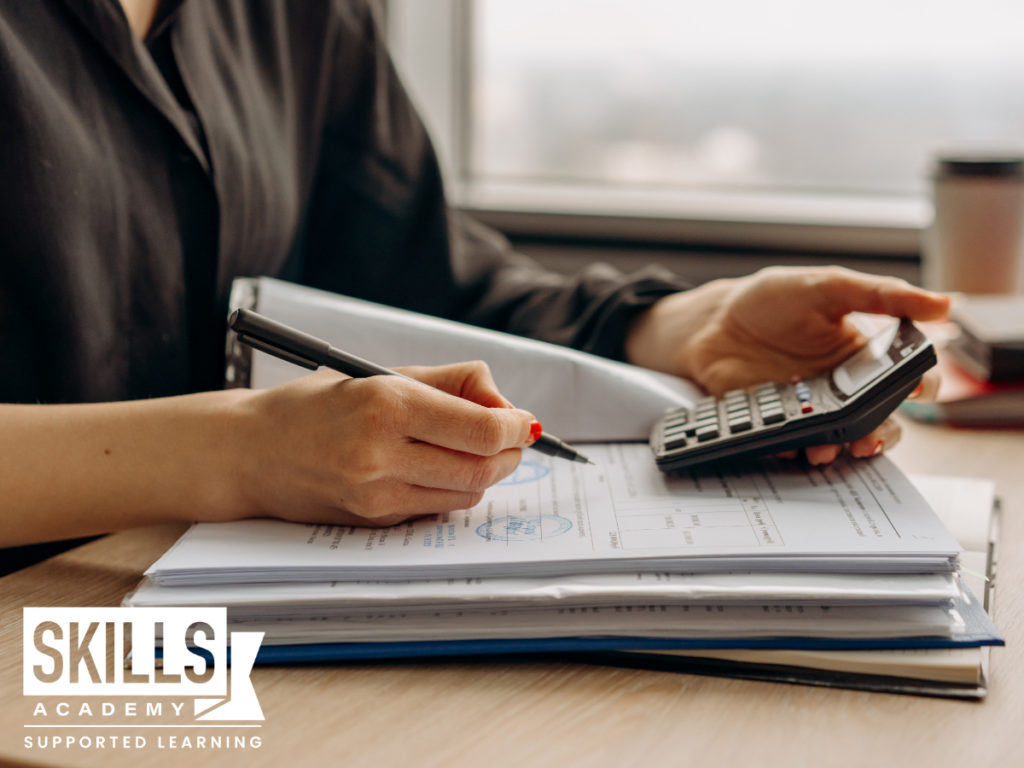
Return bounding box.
[134,279,1002,695]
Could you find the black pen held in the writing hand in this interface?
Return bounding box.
[227,309,594,464]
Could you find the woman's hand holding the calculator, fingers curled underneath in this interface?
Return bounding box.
[626,266,949,464]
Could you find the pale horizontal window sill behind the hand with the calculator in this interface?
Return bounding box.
[451,182,932,258]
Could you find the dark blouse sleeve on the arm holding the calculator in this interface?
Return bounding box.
[300,3,687,358]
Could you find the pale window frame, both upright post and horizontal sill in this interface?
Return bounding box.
[387,0,932,260]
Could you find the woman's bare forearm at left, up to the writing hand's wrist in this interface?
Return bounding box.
[0,390,246,546]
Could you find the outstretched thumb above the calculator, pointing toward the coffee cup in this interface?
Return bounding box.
[817,267,950,321]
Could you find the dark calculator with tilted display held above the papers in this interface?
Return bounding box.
[650,319,936,472]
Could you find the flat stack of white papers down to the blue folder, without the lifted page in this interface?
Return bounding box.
[132,443,1001,696]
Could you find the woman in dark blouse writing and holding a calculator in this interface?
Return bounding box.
[0,0,947,546]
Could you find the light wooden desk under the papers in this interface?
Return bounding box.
[0,425,1024,768]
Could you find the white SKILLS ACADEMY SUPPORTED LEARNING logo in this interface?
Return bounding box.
[23,607,263,748]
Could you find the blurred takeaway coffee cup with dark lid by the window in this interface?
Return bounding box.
[923,154,1024,294]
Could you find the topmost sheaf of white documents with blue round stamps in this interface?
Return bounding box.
[147,443,959,586]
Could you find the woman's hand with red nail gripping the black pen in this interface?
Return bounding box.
[224,362,540,525]
